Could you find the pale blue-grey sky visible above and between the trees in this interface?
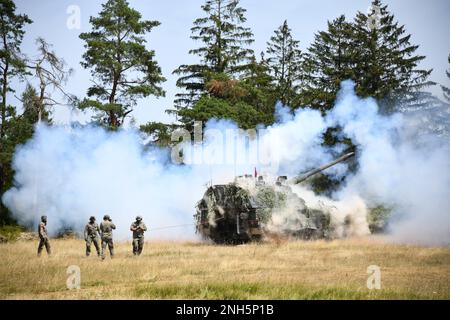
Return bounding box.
[10,0,450,124]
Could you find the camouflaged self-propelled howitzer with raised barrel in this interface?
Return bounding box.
[195,152,355,244]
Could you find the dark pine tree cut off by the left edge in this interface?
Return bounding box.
[0,0,32,223]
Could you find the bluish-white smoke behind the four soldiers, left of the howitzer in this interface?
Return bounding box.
[3,125,209,238]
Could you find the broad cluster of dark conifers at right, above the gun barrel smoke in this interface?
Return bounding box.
[301,0,434,112]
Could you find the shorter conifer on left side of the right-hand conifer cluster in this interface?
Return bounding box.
[301,15,355,112]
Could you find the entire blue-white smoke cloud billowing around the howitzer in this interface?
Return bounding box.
[2,82,450,244]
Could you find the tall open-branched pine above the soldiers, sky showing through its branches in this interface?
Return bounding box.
[79,0,165,128]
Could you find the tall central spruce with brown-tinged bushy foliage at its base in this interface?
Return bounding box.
[169,0,275,129]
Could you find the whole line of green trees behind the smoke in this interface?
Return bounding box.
[0,0,450,224]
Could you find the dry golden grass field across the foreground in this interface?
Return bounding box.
[0,238,450,299]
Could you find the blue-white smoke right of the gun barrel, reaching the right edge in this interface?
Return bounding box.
[327,81,450,245]
